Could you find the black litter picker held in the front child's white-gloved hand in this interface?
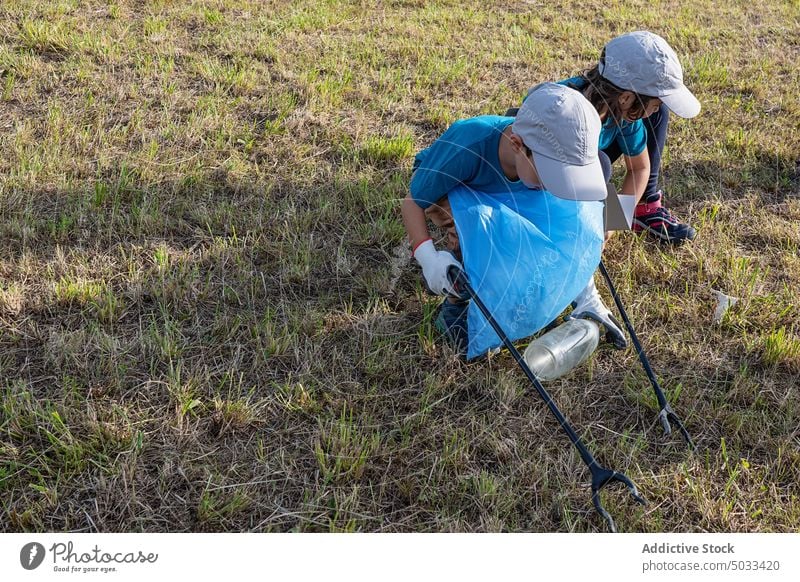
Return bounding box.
[448,266,646,532]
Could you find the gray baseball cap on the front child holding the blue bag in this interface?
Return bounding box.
[511,83,606,200]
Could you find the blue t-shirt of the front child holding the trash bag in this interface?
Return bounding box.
[410,115,528,209]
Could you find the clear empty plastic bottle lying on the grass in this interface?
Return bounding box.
[522,319,600,380]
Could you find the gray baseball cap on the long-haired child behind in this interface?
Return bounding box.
[599,30,700,118]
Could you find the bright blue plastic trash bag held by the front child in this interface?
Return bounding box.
[448,186,604,359]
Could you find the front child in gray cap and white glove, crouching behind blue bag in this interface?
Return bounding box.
[402,83,625,354]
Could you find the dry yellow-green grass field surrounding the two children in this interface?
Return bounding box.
[0,0,800,532]
